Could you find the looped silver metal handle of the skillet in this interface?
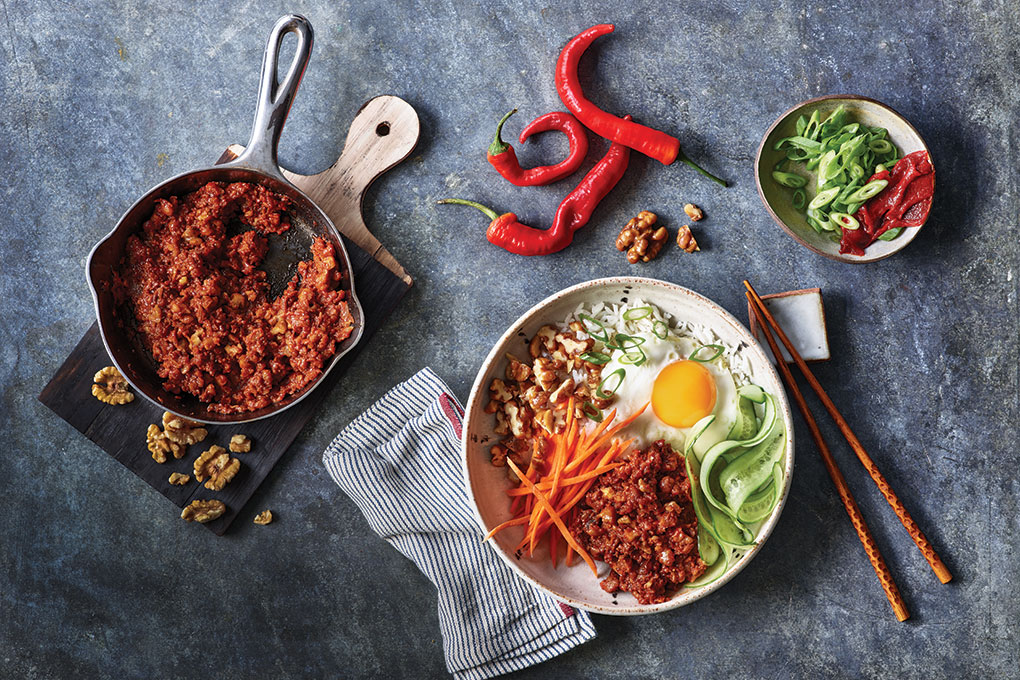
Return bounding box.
[231,14,313,178]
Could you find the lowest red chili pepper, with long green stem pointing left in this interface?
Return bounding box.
[440,126,630,255]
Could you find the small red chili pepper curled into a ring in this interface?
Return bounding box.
[488,109,588,187]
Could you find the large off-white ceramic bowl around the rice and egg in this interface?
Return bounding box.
[461,276,794,616]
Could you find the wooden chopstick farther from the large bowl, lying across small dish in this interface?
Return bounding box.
[744,280,953,583]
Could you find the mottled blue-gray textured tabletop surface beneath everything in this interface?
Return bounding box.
[0,0,1020,678]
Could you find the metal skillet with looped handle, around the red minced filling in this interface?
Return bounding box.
[86,14,364,423]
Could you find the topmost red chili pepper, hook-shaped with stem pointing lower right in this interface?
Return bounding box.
[556,23,727,187]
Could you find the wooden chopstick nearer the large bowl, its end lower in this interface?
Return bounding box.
[748,293,910,621]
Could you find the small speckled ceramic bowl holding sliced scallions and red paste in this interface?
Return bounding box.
[755,95,933,263]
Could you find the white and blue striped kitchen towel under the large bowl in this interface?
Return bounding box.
[322,368,595,680]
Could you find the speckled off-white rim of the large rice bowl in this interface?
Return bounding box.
[460,276,796,616]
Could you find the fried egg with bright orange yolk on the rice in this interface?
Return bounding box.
[602,333,737,457]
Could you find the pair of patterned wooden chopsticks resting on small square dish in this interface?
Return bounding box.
[744,279,953,621]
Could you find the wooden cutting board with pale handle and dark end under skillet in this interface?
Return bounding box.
[39,96,419,535]
